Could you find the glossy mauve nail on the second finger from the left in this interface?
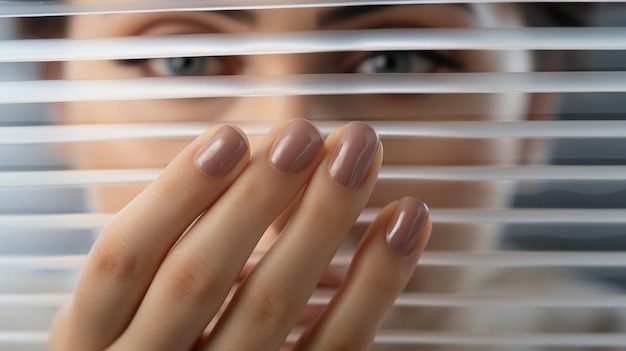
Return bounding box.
[270,119,324,173]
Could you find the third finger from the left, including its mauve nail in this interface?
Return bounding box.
[203,123,382,351]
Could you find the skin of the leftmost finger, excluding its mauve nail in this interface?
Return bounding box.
[49,126,249,351]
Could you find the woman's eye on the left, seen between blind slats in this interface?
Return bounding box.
[119,57,238,77]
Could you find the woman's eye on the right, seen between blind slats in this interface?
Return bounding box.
[350,51,463,74]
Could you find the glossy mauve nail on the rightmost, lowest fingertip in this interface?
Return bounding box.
[387,197,430,256]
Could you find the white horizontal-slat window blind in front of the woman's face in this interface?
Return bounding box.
[0,0,626,350]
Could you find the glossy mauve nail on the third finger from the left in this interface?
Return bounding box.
[329,122,380,188]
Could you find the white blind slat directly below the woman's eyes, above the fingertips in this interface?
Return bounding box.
[0,71,626,104]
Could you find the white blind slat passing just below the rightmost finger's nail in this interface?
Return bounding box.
[0,251,626,270]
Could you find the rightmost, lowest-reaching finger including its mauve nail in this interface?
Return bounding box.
[294,198,431,351]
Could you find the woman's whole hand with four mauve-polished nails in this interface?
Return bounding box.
[49,120,430,351]
